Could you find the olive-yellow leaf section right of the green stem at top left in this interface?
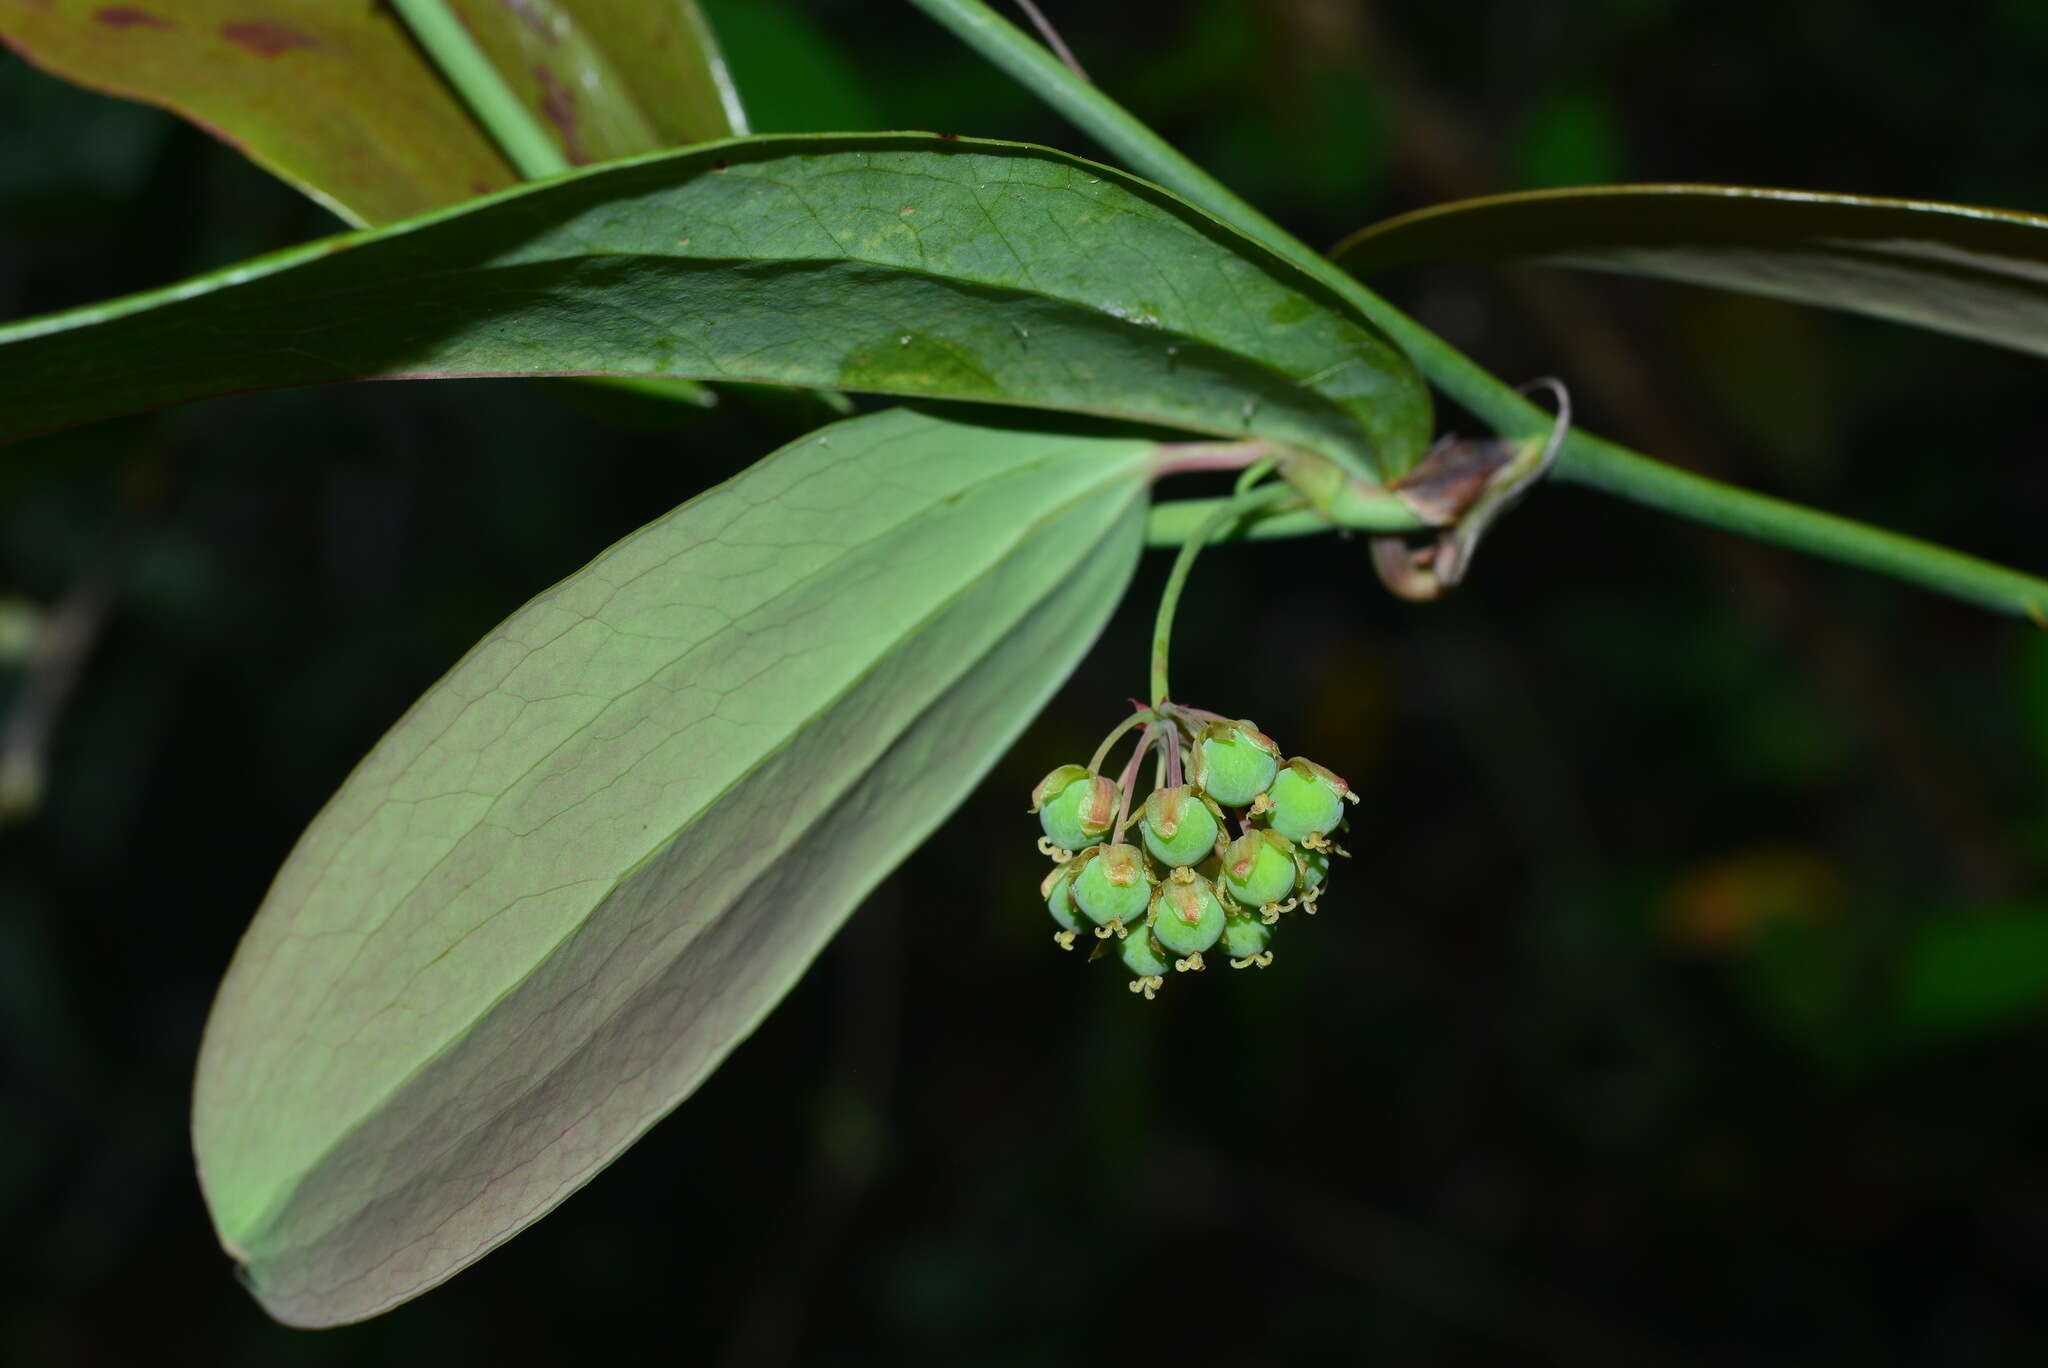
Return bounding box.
[449,0,748,166]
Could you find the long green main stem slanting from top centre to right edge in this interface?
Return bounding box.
[911,0,2048,623]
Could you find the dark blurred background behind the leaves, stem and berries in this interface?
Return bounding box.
[0,0,2048,1366]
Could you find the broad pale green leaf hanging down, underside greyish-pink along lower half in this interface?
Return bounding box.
[193,410,1155,1325]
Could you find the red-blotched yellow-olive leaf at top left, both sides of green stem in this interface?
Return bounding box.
[0,0,745,225]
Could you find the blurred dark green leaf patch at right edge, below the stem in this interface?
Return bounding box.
[1898,905,2048,1044]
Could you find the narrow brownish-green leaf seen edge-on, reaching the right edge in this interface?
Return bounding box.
[1333,184,2048,356]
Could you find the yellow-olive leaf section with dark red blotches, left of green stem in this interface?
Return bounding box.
[0,0,518,225]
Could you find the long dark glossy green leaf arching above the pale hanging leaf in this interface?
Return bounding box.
[0,133,1430,473]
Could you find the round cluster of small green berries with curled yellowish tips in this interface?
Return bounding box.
[1032,702,1358,999]
